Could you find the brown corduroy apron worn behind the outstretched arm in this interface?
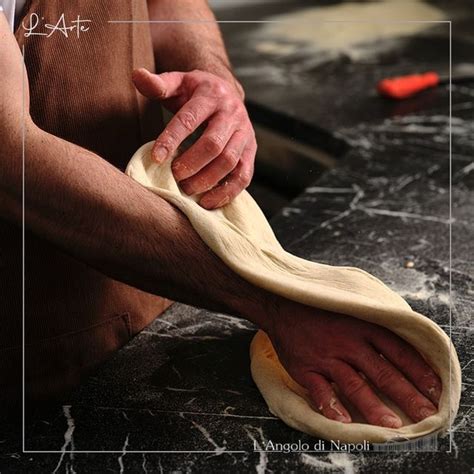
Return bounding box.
[0,0,170,399]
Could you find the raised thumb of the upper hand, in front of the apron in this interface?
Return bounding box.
[132,68,185,100]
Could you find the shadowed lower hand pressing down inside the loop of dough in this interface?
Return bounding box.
[269,302,441,428]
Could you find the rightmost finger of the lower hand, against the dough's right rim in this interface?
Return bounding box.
[370,331,442,405]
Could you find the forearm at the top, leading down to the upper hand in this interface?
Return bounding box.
[148,0,244,97]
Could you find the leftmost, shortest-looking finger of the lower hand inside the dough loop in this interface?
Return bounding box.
[302,372,352,423]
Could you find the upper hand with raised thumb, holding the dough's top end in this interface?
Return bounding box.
[133,69,257,209]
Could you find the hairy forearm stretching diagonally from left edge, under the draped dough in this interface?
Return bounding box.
[0,124,274,328]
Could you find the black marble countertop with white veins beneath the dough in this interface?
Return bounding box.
[0,1,474,474]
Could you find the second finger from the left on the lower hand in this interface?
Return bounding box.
[330,362,402,428]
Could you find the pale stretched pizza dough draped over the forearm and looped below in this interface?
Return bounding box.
[126,143,461,442]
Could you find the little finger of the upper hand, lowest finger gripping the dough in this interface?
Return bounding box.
[199,142,257,209]
